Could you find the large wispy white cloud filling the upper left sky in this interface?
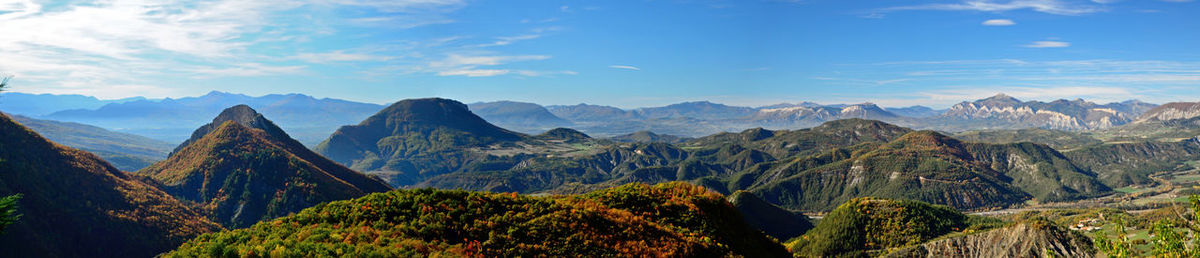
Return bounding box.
[0,0,466,96]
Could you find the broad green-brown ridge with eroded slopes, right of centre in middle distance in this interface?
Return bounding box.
[734,131,1111,210]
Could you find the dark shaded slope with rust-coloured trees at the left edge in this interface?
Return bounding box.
[0,114,221,257]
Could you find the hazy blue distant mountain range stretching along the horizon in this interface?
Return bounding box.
[0,91,1180,146]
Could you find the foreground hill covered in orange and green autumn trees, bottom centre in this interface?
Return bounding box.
[167,184,788,257]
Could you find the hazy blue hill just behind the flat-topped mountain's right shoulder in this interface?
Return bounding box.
[468,101,571,133]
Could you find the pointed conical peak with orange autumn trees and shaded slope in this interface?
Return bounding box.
[139,106,390,228]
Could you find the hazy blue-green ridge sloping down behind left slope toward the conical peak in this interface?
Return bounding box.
[12,115,172,172]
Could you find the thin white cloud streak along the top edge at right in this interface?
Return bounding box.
[878,0,1105,16]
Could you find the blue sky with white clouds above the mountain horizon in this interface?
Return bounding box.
[0,0,1200,108]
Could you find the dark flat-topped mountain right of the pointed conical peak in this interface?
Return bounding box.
[316,98,529,186]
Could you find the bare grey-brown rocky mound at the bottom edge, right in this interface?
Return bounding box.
[888,220,1096,257]
